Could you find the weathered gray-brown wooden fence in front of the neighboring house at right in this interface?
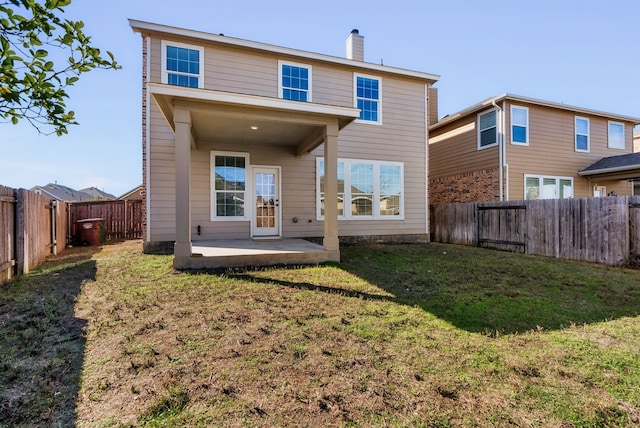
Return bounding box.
[430,196,640,265]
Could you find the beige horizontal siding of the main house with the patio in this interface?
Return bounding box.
[148,33,427,241]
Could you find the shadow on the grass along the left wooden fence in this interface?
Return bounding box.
[0,249,96,426]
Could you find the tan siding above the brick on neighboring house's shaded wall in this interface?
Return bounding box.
[429,112,500,179]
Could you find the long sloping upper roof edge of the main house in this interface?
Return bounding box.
[129,19,440,84]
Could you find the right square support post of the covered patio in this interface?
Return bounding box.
[322,122,340,261]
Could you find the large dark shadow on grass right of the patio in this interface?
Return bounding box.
[222,244,640,336]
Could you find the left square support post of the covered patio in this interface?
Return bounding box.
[173,108,191,264]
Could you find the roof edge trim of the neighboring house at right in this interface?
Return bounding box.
[429,93,640,130]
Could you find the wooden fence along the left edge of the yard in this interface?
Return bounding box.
[0,186,67,282]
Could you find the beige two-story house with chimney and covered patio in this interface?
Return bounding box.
[129,20,439,267]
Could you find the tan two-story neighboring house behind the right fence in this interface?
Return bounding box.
[429,94,640,203]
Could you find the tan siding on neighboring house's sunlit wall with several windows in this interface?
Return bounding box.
[505,103,633,200]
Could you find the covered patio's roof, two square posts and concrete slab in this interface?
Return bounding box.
[149,84,359,269]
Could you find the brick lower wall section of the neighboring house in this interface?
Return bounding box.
[429,168,500,204]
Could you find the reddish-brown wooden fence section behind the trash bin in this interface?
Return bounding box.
[69,199,143,244]
